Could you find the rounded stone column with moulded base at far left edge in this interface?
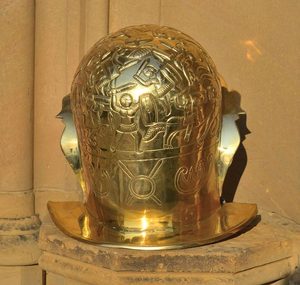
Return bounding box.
[0,0,40,284]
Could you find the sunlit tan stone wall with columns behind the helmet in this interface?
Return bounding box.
[0,0,300,284]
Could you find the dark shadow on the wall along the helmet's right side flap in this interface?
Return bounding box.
[221,88,251,202]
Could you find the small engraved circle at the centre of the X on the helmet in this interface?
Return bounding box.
[129,175,155,199]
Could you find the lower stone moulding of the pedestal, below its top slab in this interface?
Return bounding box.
[39,252,291,285]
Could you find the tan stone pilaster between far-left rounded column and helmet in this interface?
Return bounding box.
[34,0,108,217]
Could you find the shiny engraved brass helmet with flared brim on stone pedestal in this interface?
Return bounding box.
[48,25,257,249]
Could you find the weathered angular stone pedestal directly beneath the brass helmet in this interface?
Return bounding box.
[39,209,300,285]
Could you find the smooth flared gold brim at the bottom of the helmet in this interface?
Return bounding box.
[48,202,257,250]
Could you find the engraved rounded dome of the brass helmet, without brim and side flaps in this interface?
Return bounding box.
[71,25,221,222]
